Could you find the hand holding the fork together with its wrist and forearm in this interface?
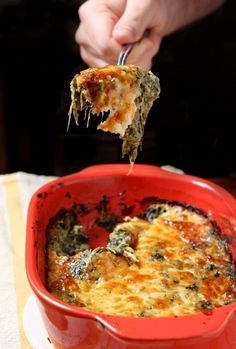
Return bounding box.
[76,0,224,69]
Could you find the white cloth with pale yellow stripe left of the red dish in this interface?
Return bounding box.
[0,172,52,349]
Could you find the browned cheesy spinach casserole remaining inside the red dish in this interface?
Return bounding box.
[47,200,236,317]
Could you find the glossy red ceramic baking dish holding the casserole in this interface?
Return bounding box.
[26,165,236,349]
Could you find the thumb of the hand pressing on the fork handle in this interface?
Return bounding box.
[112,0,154,44]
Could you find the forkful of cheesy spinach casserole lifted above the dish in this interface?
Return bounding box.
[69,64,160,164]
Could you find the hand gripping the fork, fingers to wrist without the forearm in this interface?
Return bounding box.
[76,0,166,69]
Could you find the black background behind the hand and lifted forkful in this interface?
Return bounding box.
[0,0,236,177]
